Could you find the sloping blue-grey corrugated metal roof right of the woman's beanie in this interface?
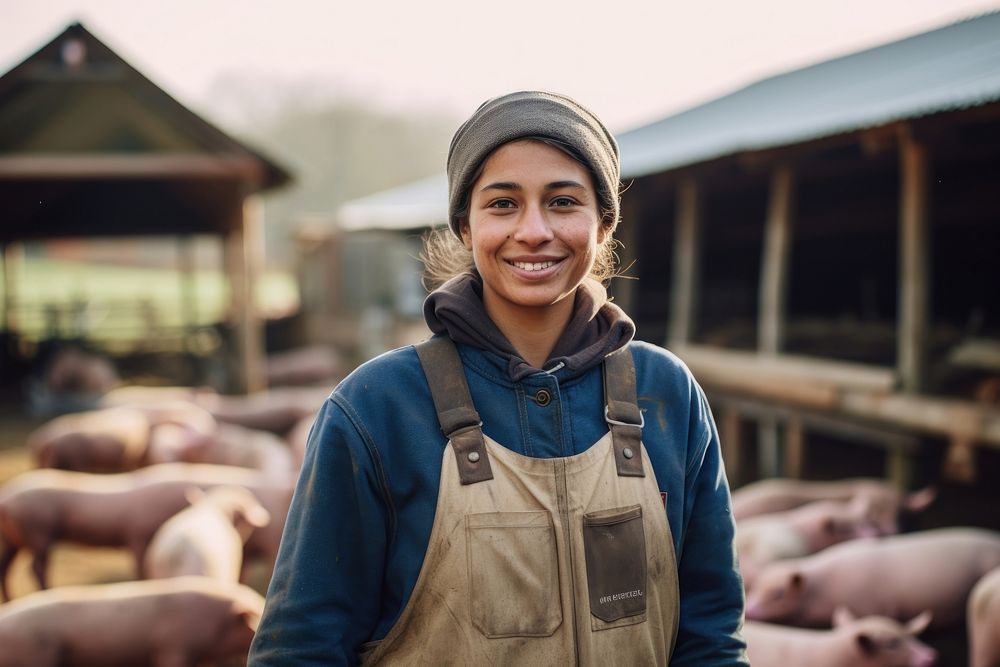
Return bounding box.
[618,12,1000,178]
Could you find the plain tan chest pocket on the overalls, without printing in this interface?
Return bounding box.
[465,511,562,638]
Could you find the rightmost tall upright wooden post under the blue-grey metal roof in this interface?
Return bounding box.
[896,125,930,393]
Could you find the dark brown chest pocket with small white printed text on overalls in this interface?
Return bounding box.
[583,505,647,630]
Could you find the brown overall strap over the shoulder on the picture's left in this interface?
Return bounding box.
[414,336,493,484]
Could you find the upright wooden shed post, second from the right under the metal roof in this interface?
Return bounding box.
[757,165,793,354]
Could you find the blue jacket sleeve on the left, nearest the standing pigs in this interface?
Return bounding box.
[248,398,389,667]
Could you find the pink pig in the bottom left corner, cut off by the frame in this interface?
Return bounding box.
[0,577,264,667]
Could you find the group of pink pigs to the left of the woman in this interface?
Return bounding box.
[0,386,329,667]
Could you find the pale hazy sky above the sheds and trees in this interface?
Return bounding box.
[0,0,1000,132]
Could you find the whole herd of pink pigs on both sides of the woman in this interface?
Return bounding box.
[0,374,1000,667]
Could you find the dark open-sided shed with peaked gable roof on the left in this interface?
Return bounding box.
[0,24,290,389]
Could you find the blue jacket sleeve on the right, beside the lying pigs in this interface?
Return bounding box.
[670,381,749,667]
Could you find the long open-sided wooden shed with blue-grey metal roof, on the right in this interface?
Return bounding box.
[616,13,1000,483]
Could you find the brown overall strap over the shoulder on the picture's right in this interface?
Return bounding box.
[604,346,646,477]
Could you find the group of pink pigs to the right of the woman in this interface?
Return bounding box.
[733,479,1000,667]
